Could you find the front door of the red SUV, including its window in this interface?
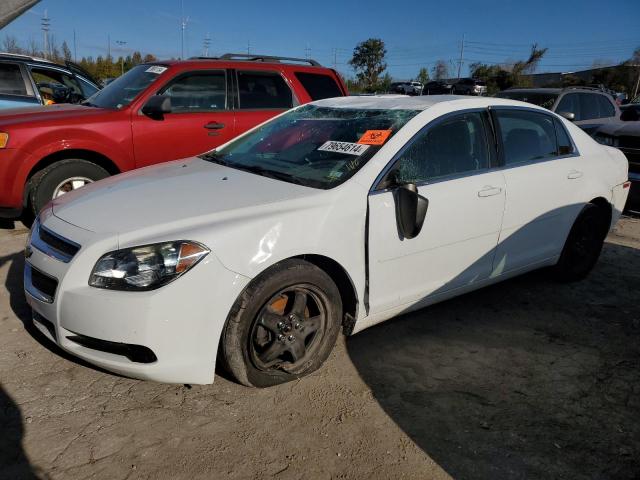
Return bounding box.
[132,69,235,167]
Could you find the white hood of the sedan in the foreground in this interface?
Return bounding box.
[52,158,318,234]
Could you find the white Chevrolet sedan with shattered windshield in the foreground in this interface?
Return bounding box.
[24,96,629,387]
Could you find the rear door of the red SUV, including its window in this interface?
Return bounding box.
[234,70,298,139]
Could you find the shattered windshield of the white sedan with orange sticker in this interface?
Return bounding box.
[201,105,418,189]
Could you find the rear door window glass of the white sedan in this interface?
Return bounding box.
[494,110,558,165]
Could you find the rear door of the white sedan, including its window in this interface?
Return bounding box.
[492,108,584,275]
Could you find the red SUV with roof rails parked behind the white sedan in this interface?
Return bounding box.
[0,54,347,220]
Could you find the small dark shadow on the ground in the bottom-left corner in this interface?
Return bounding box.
[0,385,38,480]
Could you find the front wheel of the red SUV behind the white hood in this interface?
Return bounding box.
[29,159,109,216]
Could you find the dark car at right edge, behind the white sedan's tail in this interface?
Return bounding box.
[593,121,640,213]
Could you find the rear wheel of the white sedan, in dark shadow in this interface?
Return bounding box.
[555,203,610,282]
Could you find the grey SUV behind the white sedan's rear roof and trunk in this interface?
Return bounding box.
[496,87,620,134]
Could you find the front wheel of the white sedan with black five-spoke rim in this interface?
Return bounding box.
[219,259,342,388]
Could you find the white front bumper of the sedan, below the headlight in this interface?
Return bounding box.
[24,215,249,384]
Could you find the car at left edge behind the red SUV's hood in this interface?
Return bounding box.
[0,53,100,111]
